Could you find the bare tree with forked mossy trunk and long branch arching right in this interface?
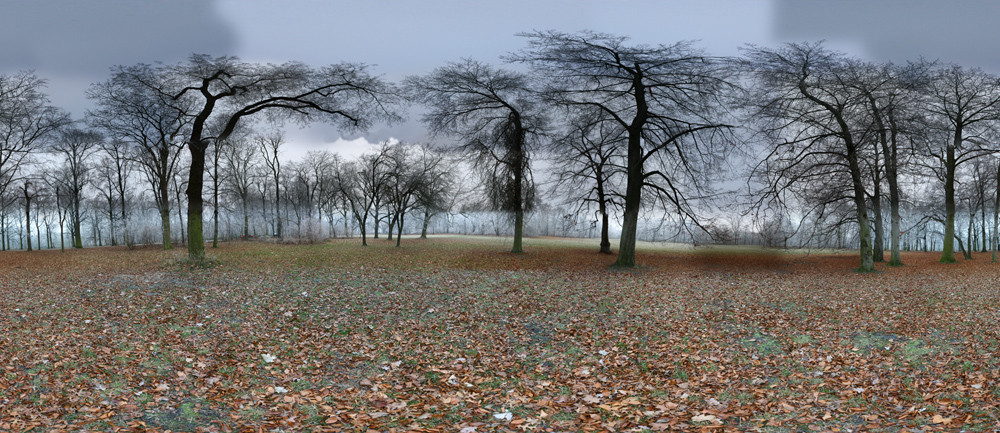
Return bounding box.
[115,55,398,262]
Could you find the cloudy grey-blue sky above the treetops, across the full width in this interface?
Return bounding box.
[0,0,1000,157]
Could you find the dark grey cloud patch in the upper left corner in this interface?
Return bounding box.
[0,0,236,76]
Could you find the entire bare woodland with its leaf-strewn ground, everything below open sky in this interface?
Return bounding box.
[0,31,1000,433]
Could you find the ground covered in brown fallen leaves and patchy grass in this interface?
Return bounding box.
[0,237,1000,433]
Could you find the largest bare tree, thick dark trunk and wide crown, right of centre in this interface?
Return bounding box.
[512,31,735,267]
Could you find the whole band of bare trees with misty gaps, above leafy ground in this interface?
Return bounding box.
[0,31,1000,271]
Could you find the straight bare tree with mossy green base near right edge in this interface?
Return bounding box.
[922,65,1000,263]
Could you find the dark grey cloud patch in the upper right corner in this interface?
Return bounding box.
[774,0,1000,72]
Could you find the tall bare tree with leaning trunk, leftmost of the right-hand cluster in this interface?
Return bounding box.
[743,43,874,272]
